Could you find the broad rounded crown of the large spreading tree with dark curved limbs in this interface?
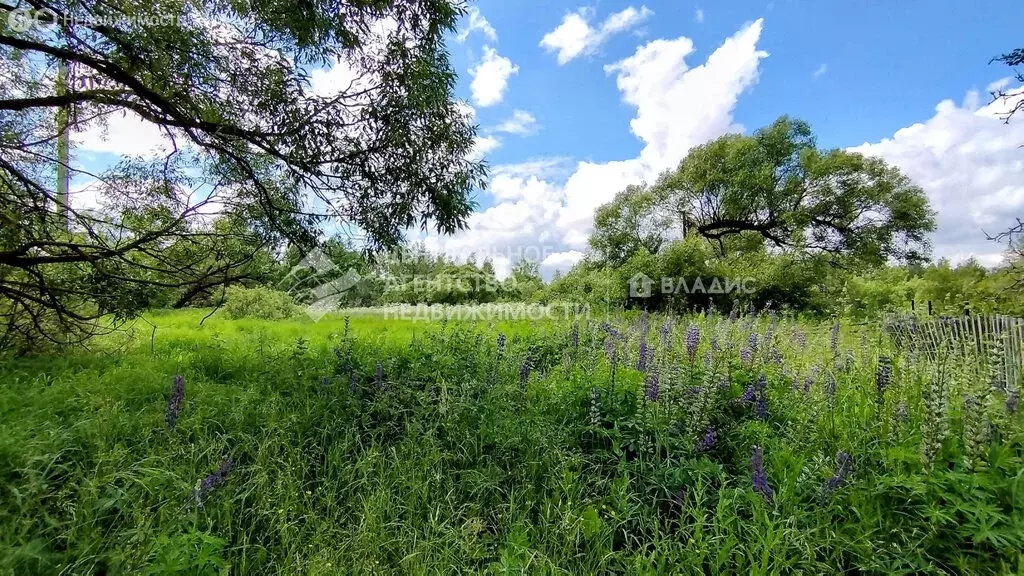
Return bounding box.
[595,117,935,264]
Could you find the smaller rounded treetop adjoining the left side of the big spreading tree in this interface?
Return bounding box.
[590,184,671,265]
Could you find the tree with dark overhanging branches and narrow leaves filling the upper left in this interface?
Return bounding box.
[0,0,485,350]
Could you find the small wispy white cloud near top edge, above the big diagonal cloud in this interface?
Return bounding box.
[541,6,654,65]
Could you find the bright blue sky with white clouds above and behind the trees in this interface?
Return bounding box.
[75,0,1024,277]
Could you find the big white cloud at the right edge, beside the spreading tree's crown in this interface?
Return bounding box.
[850,85,1024,264]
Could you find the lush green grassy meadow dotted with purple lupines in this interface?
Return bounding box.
[0,311,1024,575]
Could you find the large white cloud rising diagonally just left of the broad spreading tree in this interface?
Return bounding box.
[425,20,767,278]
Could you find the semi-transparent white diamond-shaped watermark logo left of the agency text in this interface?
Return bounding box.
[278,250,361,322]
